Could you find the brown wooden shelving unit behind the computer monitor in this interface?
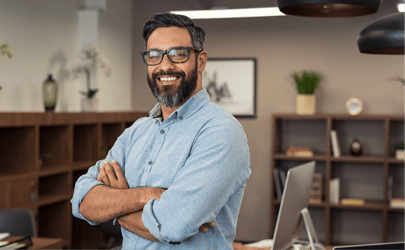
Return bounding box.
[269,113,404,245]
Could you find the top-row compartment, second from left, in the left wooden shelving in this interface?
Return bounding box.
[39,126,71,169]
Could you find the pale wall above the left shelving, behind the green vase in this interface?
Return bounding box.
[0,0,132,112]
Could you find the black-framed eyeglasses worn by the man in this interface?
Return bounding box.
[141,47,202,66]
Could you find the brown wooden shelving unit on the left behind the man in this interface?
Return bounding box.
[0,112,148,249]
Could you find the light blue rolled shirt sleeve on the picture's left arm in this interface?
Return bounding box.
[70,128,129,226]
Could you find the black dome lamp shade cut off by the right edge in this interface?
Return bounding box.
[357,13,405,55]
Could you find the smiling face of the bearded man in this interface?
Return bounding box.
[147,27,198,108]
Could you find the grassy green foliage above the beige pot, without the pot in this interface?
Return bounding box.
[291,70,324,95]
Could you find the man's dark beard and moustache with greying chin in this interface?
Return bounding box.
[146,63,198,108]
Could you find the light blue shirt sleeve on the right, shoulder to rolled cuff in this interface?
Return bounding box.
[142,120,251,244]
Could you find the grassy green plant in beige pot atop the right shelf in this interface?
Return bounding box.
[291,70,324,115]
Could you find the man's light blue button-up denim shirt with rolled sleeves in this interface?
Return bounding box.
[71,89,251,250]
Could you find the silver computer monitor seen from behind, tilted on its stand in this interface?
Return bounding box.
[271,161,317,250]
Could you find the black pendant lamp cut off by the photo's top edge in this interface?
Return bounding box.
[277,0,381,17]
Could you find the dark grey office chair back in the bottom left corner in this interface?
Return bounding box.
[0,208,37,237]
